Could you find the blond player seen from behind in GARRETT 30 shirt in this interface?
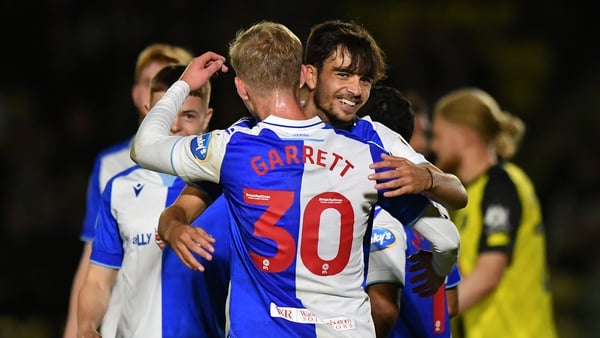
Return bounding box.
[132,22,458,337]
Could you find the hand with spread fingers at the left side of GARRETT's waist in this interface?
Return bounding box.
[168,223,215,271]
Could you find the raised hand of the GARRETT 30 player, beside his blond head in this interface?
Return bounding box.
[179,52,229,90]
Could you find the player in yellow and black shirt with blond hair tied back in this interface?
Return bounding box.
[431,88,557,338]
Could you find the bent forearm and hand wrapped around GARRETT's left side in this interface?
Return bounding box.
[158,184,215,271]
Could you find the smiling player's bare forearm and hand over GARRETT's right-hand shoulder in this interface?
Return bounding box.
[369,154,468,209]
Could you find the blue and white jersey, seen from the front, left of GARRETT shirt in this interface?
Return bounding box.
[90,166,227,338]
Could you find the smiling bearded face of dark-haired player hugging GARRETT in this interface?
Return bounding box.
[306,48,373,128]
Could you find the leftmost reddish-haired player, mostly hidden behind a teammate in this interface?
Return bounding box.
[64,43,192,338]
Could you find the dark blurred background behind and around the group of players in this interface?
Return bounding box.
[0,0,600,338]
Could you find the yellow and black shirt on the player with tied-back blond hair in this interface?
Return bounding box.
[451,162,557,338]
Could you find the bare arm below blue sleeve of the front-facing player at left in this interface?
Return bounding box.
[77,263,118,338]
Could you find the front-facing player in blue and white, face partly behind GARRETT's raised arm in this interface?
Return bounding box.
[77,65,223,338]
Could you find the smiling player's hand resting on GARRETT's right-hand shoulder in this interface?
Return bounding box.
[369,154,431,197]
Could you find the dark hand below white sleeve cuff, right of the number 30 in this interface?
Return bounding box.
[406,250,446,297]
